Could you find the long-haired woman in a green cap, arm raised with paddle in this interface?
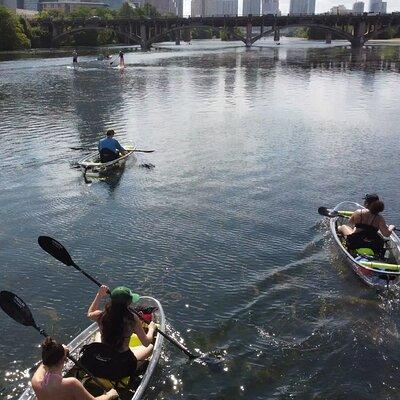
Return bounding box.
[87,285,155,376]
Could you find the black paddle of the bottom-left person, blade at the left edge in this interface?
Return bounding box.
[0,290,115,391]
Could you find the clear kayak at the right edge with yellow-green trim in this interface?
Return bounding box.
[330,201,400,288]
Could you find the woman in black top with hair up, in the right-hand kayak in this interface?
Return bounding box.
[338,193,395,256]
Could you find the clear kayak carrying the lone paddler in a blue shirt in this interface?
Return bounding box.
[78,145,135,177]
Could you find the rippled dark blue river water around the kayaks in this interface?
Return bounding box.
[0,40,400,400]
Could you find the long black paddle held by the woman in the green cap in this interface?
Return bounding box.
[38,236,200,359]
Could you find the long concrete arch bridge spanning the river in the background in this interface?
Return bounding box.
[32,13,400,51]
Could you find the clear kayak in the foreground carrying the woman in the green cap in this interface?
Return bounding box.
[19,296,165,400]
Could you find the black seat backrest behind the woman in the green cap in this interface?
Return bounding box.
[79,342,136,381]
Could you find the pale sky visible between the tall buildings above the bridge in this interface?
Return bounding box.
[183,0,400,15]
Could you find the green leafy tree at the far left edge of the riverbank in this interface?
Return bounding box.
[0,6,31,50]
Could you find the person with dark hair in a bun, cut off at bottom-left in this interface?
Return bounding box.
[31,337,118,400]
